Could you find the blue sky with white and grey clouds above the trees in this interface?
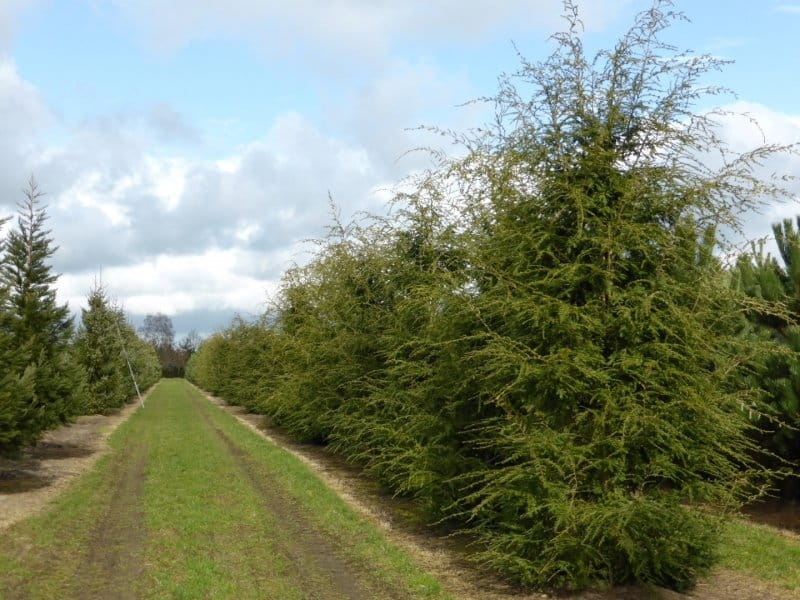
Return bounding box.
[0,0,800,335]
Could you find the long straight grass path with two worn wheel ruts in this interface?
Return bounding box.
[0,380,446,600]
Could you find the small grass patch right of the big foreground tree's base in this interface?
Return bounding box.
[720,521,800,590]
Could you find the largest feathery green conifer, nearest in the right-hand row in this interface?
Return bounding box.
[410,0,789,589]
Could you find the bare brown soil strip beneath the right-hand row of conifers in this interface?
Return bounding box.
[195,390,797,600]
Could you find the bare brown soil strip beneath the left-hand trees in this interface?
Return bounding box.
[0,392,151,530]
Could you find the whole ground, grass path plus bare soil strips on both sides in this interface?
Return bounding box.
[0,381,797,600]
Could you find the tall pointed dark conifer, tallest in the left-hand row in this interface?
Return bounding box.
[0,177,82,437]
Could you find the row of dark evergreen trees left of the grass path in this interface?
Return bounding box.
[0,179,160,453]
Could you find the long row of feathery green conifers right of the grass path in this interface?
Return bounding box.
[187,0,800,589]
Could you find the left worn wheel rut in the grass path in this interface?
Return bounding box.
[73,440,148,600]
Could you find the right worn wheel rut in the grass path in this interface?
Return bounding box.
[199,398,392,600]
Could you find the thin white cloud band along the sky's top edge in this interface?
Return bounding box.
[100,0,633,61]
